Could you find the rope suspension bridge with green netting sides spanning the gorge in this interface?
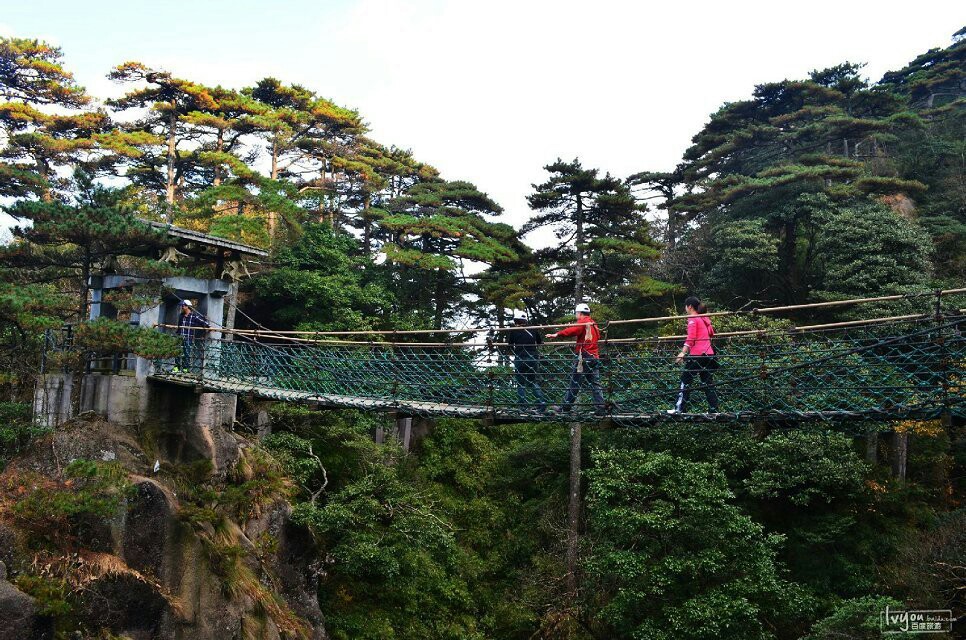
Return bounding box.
[152,289,966,423]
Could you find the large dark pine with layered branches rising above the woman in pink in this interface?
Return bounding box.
[669,63,925,304]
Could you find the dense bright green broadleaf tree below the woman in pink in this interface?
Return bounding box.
[586,451,800,640]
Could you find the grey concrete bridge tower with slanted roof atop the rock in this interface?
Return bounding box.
[34,223,268,466]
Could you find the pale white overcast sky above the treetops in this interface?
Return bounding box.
[0,0,966,230]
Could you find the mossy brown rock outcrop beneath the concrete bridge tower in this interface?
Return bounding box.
[0,415,326,640]
